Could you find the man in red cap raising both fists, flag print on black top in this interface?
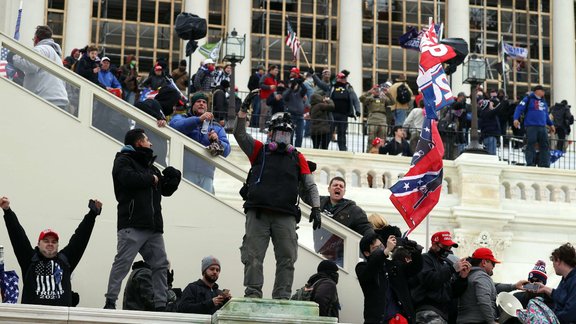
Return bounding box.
[0,197,102,307]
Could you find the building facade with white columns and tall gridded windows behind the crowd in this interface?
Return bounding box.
[0,0,576,103]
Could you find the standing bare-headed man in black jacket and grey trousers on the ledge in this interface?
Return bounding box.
[104,128,181,311]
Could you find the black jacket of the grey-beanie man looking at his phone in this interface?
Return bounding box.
[174,279,223,315]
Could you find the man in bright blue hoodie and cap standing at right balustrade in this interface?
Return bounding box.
[514,85,556,168]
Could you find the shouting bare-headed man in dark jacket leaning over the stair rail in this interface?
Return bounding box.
[313,177,374,266]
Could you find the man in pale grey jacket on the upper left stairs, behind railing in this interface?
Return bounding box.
[8,26,68,109]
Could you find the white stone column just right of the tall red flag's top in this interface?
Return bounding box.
[445,0,470,96]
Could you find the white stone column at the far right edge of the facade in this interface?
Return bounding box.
[550,0,576,139]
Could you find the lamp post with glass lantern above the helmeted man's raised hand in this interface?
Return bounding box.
[224,28,246,133]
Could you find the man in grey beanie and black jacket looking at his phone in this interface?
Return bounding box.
[174,255,232,315]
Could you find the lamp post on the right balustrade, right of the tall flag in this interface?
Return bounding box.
[462,54,488,154]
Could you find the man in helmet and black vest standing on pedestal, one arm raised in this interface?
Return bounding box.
[234,92,321,299]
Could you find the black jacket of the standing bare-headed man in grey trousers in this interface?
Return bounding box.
[112,145,181,233]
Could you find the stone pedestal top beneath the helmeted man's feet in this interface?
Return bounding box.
[212,298,338,324]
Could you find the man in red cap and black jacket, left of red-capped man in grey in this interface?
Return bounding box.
[412,231,471,324]
